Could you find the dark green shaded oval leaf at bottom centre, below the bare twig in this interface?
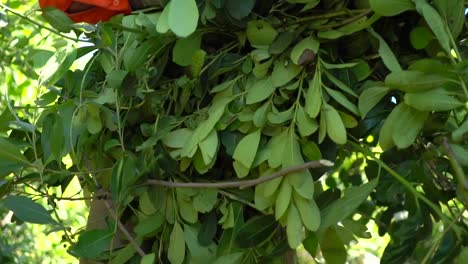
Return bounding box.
[236,215,278,248]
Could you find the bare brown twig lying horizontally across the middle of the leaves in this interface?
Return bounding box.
[145,160,334,189]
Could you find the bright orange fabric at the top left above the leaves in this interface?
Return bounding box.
[39,0,132,24]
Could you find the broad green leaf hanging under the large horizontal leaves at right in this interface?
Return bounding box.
[392,103,428,148]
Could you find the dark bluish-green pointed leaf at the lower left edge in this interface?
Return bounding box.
[3,195,57,224]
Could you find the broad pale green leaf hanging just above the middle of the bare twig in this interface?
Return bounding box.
[232,129,262,169]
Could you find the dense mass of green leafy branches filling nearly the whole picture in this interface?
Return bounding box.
[0,0,468,263]
